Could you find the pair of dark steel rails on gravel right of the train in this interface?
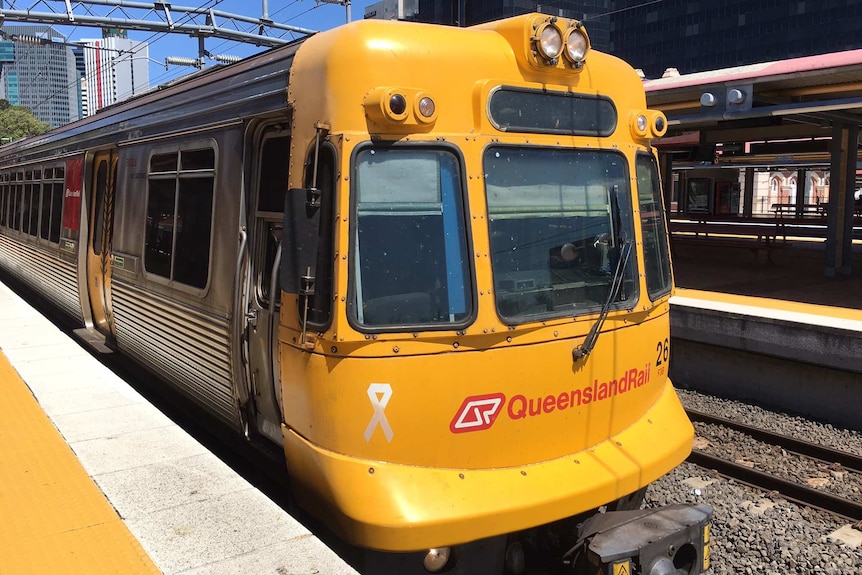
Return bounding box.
[687,409,862,522]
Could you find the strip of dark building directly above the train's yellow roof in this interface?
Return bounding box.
[365,0,611,51]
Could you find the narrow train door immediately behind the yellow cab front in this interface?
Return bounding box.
[245,125,290,443]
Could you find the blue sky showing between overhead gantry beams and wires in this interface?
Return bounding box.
[49,0,376,86]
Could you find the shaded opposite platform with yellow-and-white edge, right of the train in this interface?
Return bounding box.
[671,242,862,429]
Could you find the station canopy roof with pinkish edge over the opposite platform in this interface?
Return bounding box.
[644,50,862,167]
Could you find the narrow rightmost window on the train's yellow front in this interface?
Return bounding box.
[637,154,671,300]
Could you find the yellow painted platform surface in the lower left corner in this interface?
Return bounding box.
[0,350,161,575]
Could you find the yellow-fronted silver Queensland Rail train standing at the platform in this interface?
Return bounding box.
[0,14,711,575]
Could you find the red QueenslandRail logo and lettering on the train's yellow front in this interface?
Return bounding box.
[449,363,651,433]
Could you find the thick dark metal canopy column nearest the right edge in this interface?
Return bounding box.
[824,124,859,277]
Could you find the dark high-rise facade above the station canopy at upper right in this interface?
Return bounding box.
[610,0,862,78]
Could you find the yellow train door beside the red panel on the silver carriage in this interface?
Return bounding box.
[87,150,117,339]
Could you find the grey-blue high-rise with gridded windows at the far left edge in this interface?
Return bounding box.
[0,26,79,128]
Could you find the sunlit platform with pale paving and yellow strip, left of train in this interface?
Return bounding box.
[0,283,355,575]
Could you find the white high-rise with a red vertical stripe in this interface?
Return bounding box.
[81,29,150,115]
